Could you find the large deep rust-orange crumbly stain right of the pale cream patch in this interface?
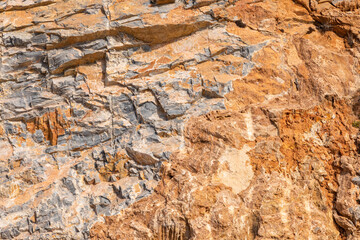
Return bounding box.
[250,99,356,206]
